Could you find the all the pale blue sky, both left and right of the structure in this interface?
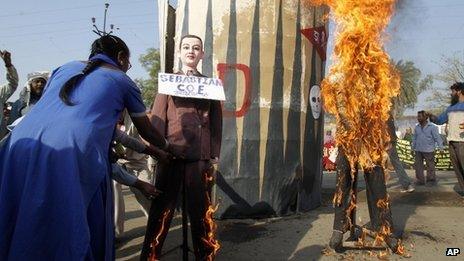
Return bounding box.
[0,0,464,113]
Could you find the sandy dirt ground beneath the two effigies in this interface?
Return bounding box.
[116,172,464,261]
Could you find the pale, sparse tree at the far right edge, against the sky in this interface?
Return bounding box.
[428,52,464,113]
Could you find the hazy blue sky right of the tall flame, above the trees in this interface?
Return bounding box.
[386,0,464,112]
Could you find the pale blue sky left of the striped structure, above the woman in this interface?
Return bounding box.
[0,0,164,98]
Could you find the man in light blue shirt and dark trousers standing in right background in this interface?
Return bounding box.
[412,111,443,185]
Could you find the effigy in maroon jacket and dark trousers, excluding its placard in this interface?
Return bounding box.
[141,35,222,260]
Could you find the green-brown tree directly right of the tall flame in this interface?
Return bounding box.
[392,60,433,118]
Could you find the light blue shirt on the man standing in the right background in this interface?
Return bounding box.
[412,122,443,152]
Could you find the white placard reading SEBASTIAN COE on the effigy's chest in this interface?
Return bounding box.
[158,73,226,101]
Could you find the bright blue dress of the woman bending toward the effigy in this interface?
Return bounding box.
[0,57,145,261]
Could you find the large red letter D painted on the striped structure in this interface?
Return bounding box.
[217,63,251,118]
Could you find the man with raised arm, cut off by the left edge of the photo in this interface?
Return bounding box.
[0,51,18,140]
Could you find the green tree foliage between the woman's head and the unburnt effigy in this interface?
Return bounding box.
[135,48,161,106]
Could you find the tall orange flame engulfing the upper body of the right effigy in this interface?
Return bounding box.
[312,0,400,168]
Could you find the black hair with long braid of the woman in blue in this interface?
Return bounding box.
[60,35,129,106]
